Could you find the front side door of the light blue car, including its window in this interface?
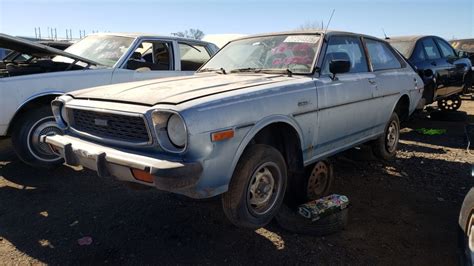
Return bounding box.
[314,36,377,156]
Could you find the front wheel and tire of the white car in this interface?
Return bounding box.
[12,106,63,168]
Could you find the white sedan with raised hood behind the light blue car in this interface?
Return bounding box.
[0,33,218,167]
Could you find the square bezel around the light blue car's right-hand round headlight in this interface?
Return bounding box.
[151,109,189,153]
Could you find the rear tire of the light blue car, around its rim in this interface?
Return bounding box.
[371,112,400,160]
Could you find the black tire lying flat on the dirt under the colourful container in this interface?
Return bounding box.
[275,204,349,236]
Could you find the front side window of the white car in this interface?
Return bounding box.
[126,41,173,70]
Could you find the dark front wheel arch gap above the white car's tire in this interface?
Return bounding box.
[7,91,64,136]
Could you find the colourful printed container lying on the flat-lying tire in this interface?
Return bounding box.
[298,194,349,221]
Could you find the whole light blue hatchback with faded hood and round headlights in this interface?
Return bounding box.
[42,31,423,228]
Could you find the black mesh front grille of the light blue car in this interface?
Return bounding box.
[67,108,150,143]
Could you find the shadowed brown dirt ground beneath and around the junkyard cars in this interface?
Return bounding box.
[0,96,474,265]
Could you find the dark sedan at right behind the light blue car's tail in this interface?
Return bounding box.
[388,36,472,110]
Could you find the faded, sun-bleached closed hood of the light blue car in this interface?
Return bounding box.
[69,74,296,106]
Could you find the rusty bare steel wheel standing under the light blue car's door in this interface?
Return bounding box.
[306,161,333,200]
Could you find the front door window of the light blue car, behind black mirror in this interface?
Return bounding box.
[321,36,369,75]
